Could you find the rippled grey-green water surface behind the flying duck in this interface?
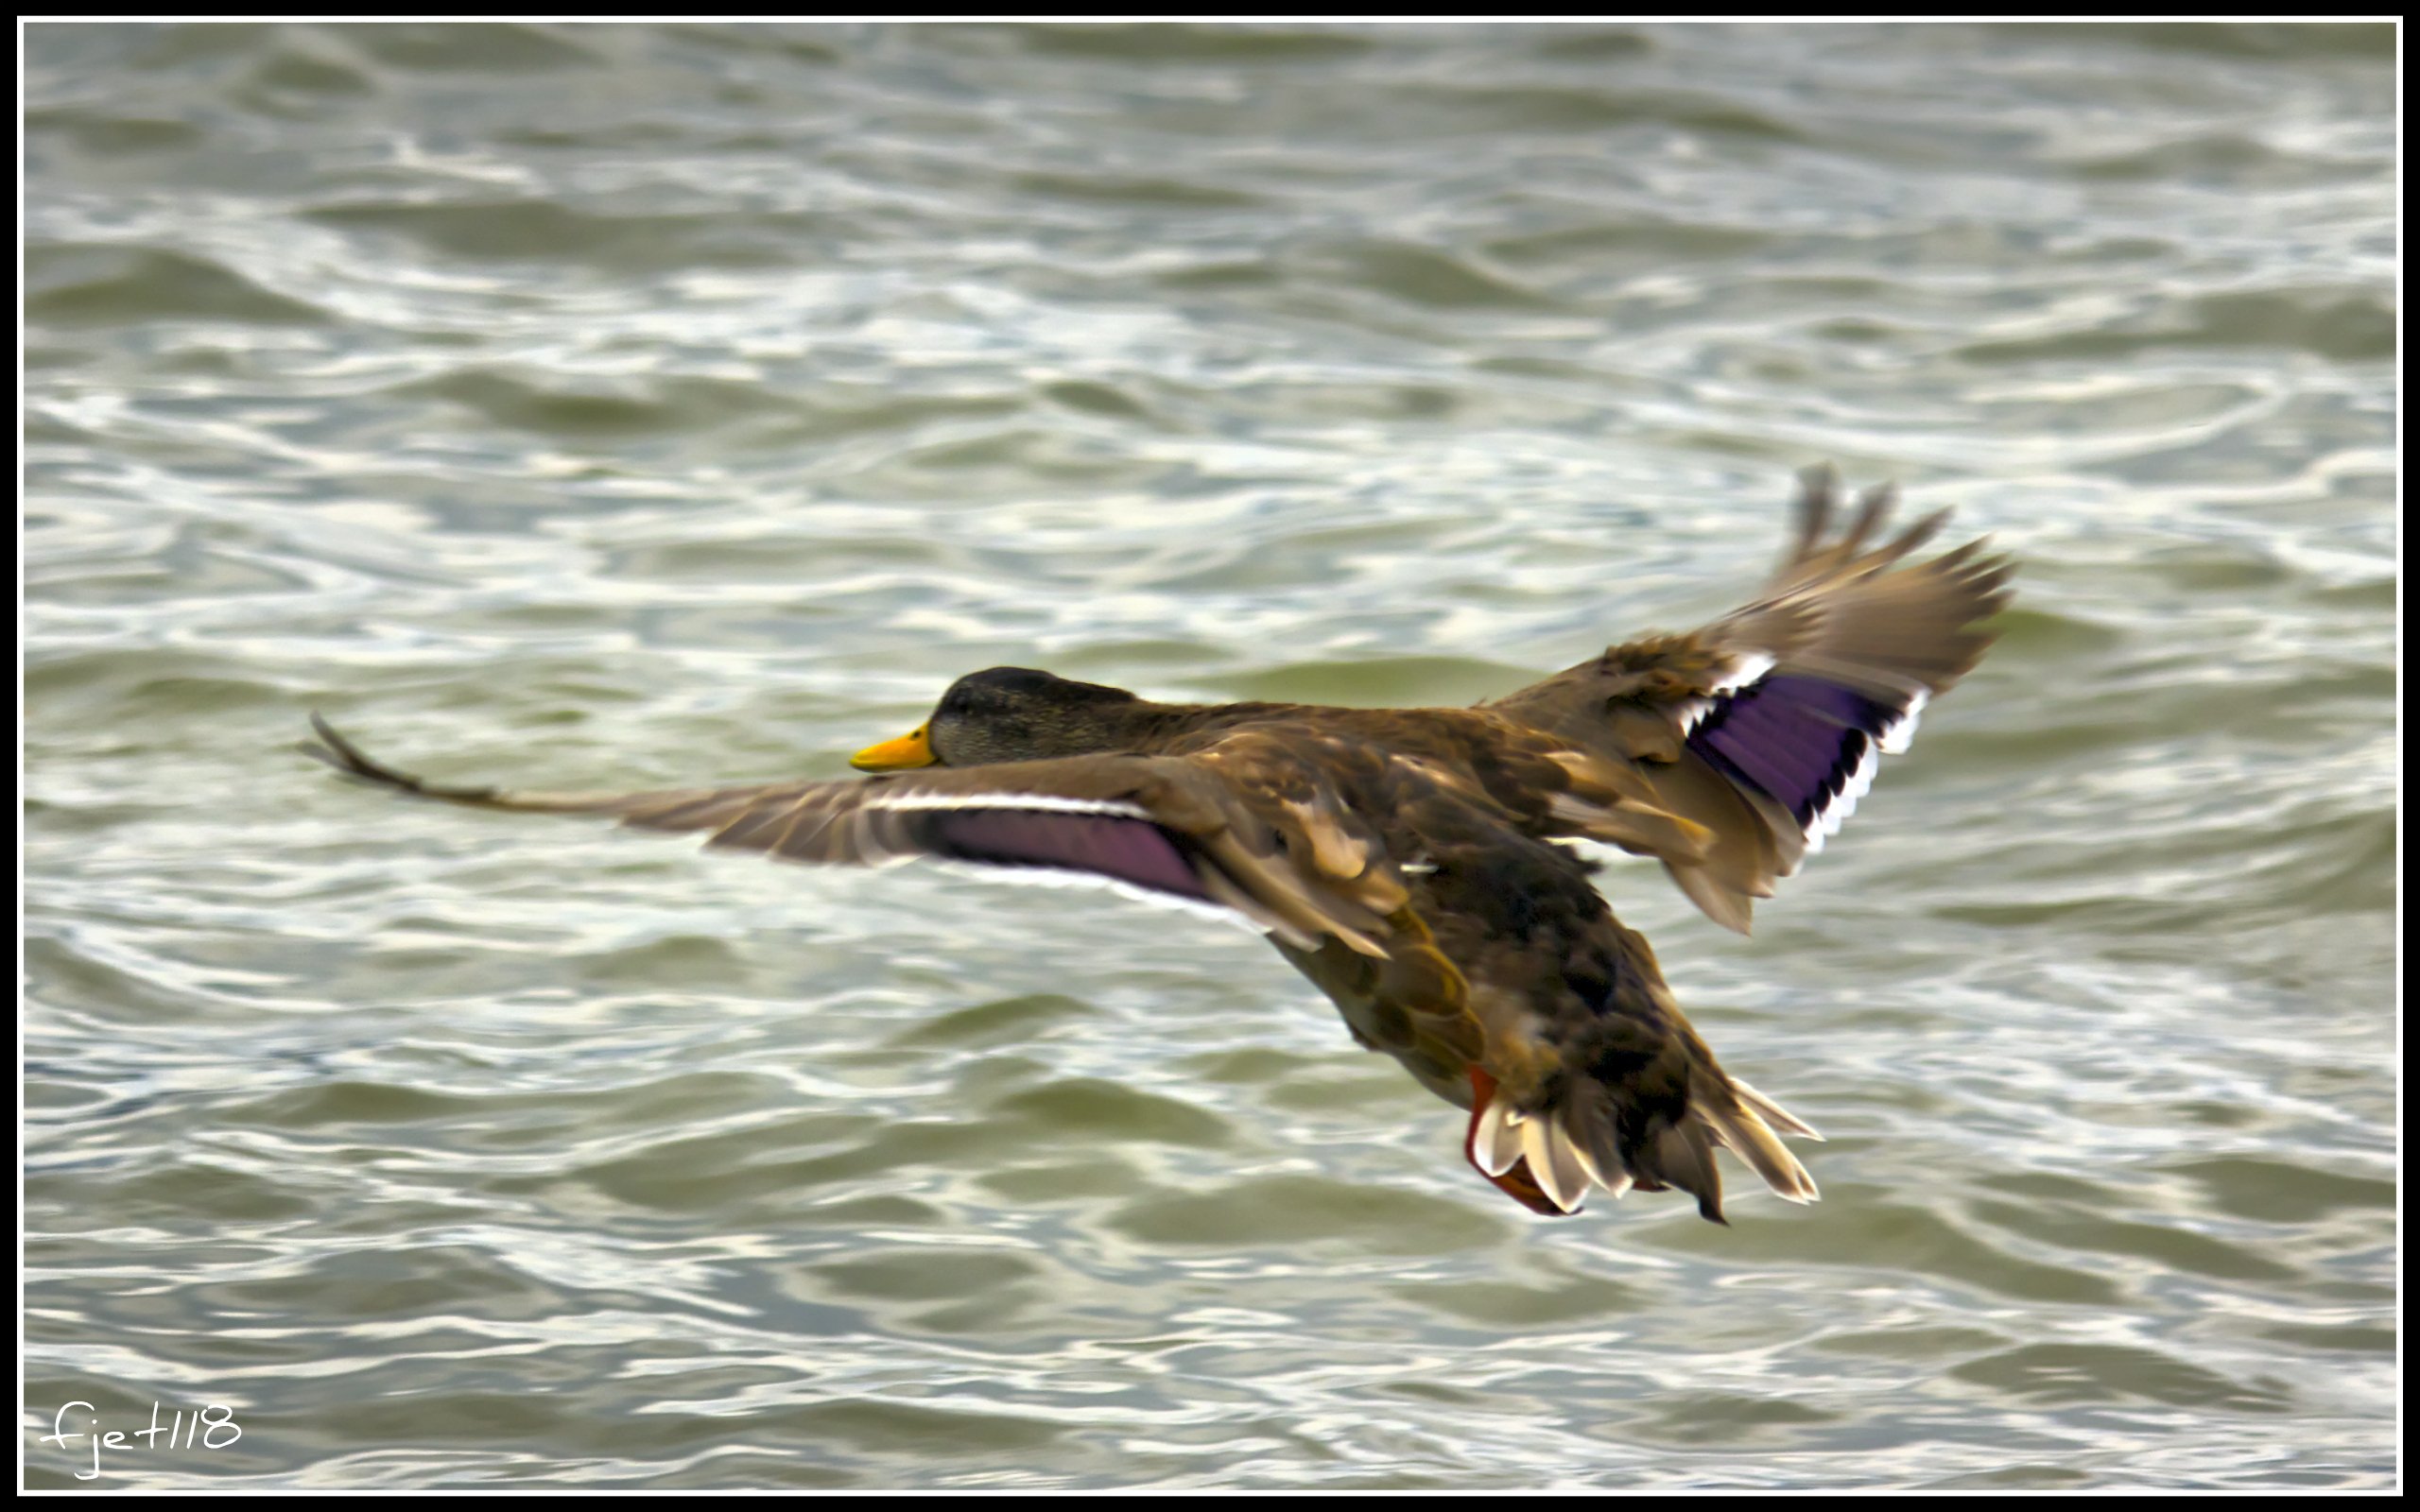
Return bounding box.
[22,26,2398,1487]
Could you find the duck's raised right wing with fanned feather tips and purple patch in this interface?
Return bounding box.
[1488,470,2014,934]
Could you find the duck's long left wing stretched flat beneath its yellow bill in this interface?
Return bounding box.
[302,713,1404,955]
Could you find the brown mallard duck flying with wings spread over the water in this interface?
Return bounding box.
[305,474,2011,1222]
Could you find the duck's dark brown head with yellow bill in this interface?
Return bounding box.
[850,668,1147,772]
